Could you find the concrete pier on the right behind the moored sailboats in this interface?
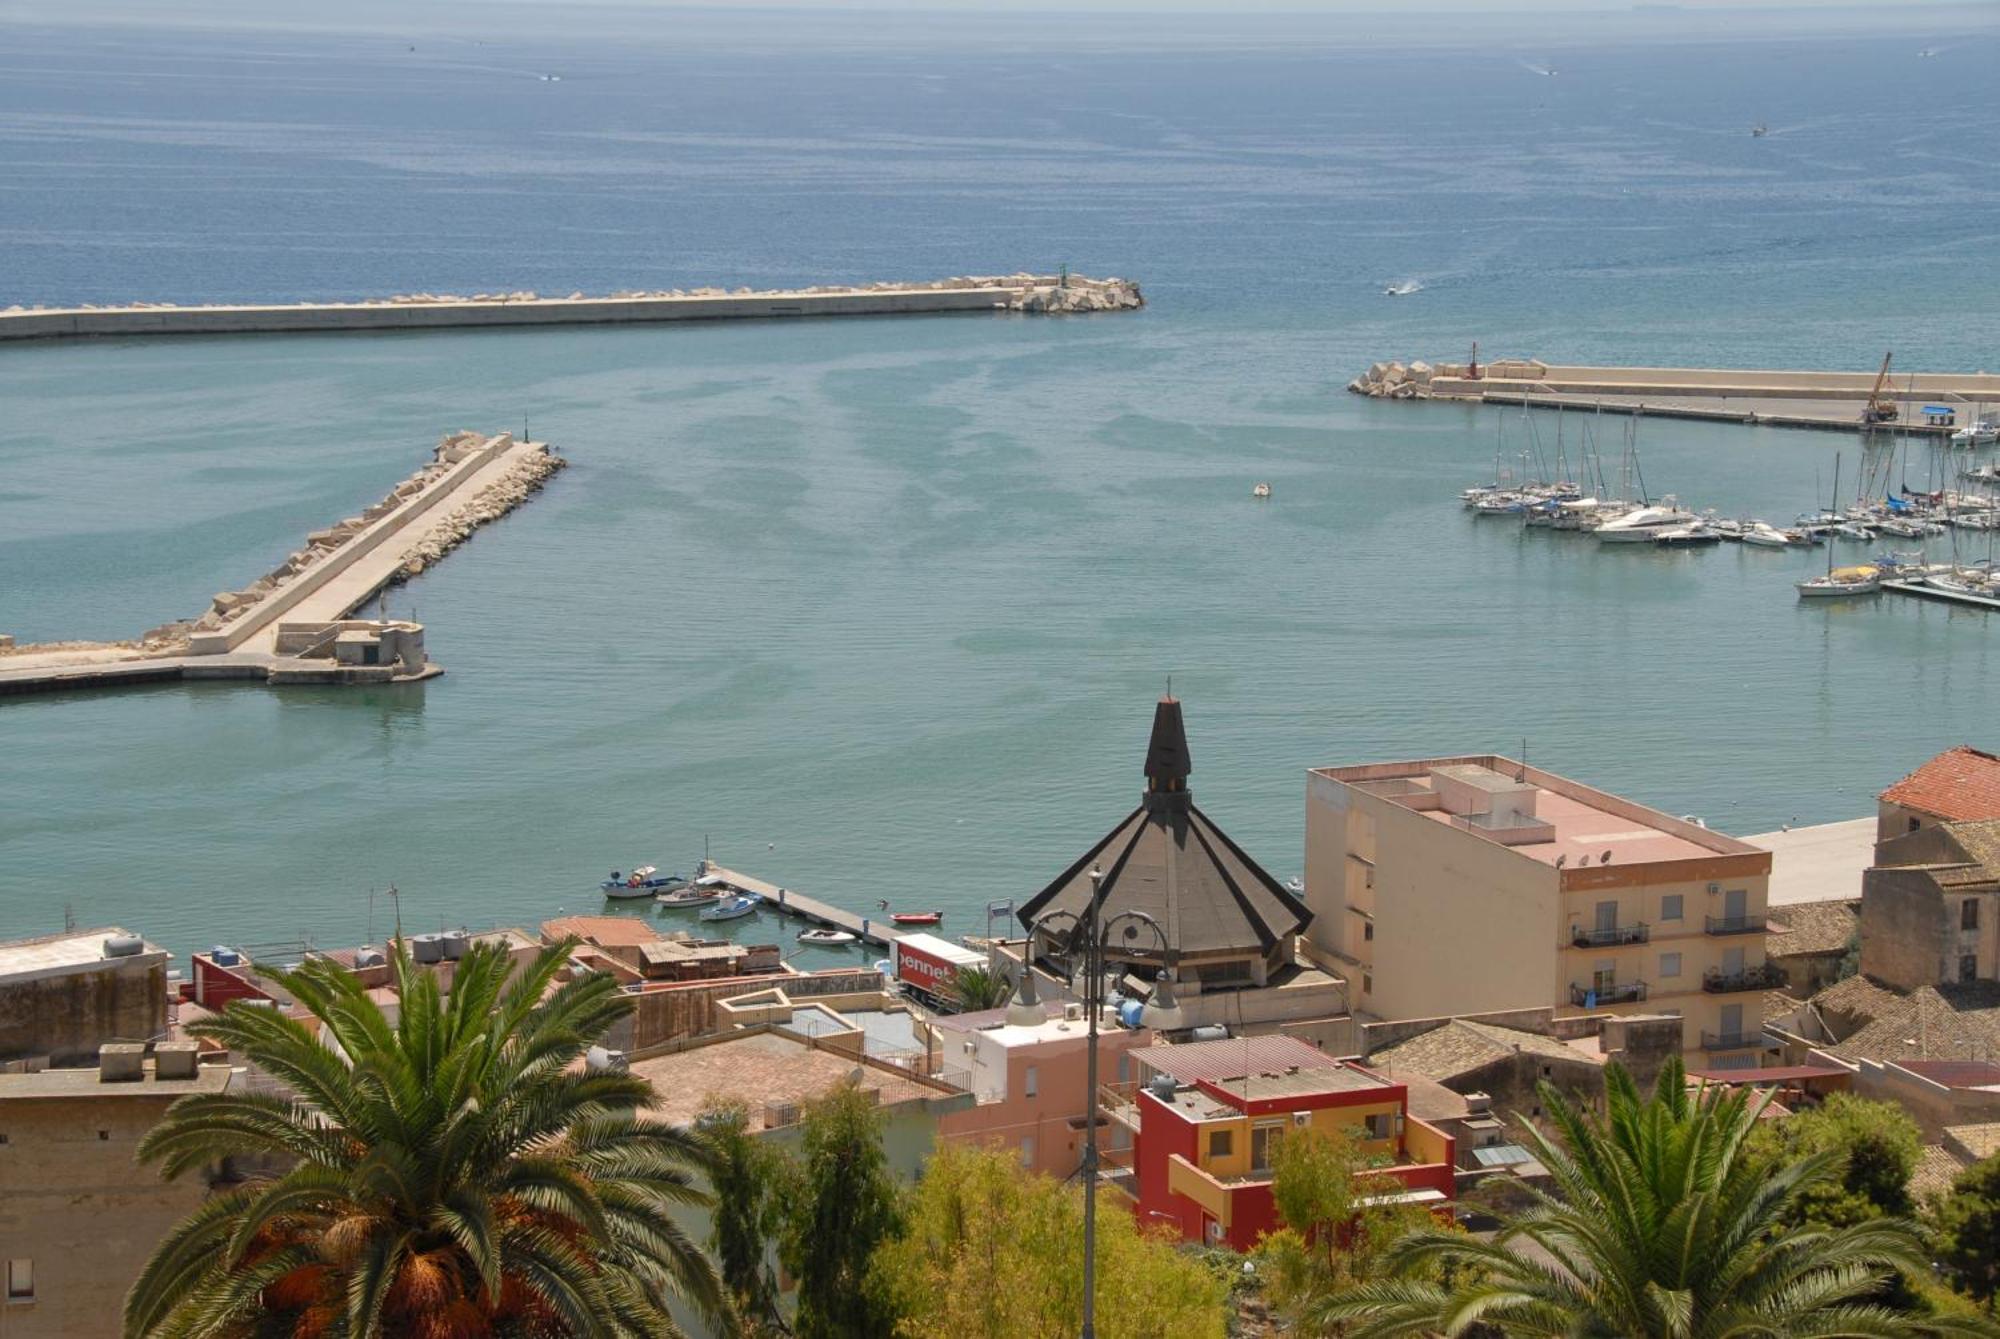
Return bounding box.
[1348,358,2000,438]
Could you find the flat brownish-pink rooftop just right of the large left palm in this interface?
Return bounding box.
[632,1031,952,1127]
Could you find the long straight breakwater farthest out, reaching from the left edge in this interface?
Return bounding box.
[0,274,1146,340]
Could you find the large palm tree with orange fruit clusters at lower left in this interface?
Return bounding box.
[124,941,722,1339]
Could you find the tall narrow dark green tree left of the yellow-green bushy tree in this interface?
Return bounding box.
[780,1083,902,1339]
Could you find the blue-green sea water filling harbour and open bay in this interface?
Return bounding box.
[0,10,2000,949]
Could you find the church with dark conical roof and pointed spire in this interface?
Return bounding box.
[1018,697,1312,989]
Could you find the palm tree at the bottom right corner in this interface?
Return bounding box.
[1302,1057,1996,1339]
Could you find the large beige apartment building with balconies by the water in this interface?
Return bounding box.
[1306,755,1782,1067]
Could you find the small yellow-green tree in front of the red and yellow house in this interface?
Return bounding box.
[1258,1131,1438,1317]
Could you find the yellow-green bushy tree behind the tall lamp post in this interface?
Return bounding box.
[874,1143,1228,1339]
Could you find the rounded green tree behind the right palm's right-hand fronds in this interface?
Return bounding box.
[1750,1093,1924,1227]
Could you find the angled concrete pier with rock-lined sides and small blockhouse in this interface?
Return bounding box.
[0,432,564,693]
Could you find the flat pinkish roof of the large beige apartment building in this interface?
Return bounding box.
[1312,753,1762,867]
